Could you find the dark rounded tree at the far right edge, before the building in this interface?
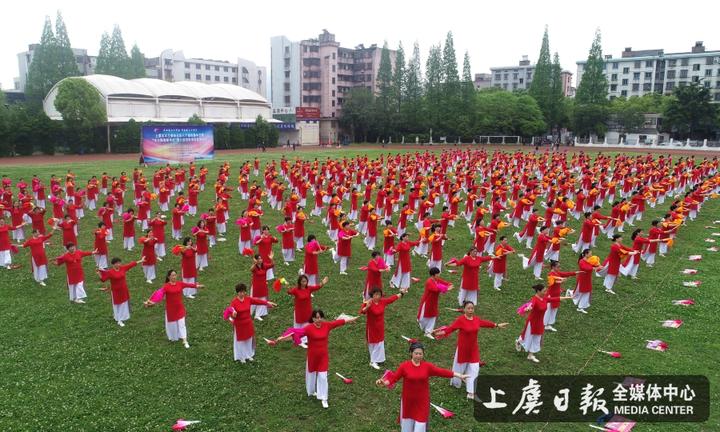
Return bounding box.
[663,83,720,139]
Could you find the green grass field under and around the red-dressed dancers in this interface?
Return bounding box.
[0,149,720,431]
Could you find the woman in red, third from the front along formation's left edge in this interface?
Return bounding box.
[230,283,277,363]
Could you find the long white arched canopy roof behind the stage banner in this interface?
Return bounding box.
[43,75,277,123]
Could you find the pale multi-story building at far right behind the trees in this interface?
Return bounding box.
[577,42,720,102]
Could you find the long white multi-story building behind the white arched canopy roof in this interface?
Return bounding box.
[145,49,267,97]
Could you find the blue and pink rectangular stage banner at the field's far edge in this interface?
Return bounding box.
[142,125,215,164]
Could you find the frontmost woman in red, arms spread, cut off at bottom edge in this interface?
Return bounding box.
[375,342,469,432]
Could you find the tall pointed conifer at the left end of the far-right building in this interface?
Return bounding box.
[573,29,609,136]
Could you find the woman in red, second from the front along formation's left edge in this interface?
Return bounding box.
[277,309,358,408]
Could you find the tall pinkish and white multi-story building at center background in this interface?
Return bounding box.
[270,30,396,142]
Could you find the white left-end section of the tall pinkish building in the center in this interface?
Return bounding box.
[270,36,301,109]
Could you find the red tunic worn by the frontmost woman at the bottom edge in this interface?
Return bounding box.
[388,360,454,423]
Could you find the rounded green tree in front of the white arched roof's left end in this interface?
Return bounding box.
[55,78,107,152]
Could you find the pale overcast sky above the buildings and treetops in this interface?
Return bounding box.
[0,0,720,89]
